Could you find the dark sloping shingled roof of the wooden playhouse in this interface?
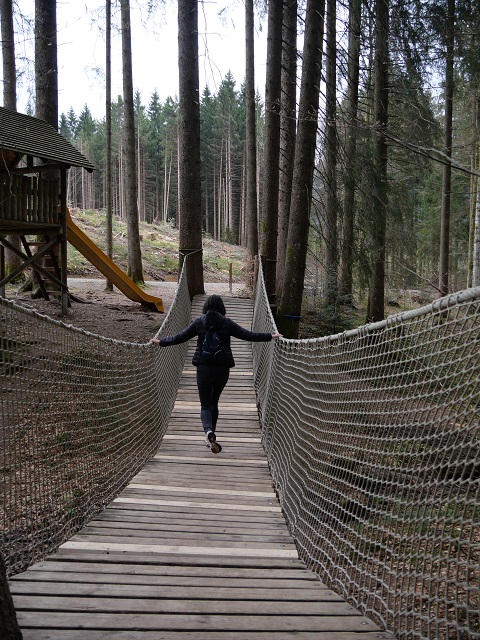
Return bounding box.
[0,107,95,171]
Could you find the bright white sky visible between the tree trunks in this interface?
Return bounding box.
[7,0,267,119]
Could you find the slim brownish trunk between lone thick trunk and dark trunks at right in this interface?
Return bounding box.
[245,0,258,267]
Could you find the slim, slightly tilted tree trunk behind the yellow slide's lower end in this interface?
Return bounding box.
[120,0,143,283]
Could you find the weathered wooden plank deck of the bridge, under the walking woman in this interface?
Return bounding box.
[7,298,392,640]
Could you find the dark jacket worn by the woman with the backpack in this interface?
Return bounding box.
[160,311,272,368]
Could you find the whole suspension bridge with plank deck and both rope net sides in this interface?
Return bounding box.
[0,262,480,640]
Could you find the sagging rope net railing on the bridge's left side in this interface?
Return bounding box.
[0,270,191,575]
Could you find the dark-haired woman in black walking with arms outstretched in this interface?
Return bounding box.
[150,295,281,453]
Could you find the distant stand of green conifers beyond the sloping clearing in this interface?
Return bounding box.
[59,73,256,244]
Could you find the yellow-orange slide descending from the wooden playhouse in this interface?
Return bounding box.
[67,210,164,313]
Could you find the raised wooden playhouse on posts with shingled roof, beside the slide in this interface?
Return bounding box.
[0,107,94,313]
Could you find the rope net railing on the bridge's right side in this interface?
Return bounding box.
[254,262,480,640]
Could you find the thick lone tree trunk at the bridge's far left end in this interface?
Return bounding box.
[178,0,204,298]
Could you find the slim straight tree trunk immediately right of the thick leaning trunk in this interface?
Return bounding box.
[325,0,338,306]
